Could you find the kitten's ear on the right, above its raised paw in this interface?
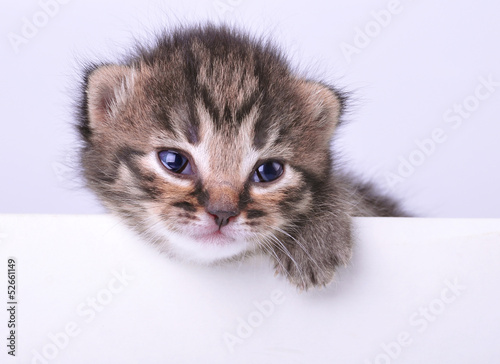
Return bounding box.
[304,81,344,140]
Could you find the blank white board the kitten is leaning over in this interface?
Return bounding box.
[0,215,500,364]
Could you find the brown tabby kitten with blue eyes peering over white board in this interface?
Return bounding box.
[79,25,402,289]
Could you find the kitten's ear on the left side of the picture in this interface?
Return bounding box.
[85,65,134,129]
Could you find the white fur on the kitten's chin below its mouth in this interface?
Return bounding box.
[156,230,250,264]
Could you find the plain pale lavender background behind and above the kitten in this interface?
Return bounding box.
[0,0,500,218]
